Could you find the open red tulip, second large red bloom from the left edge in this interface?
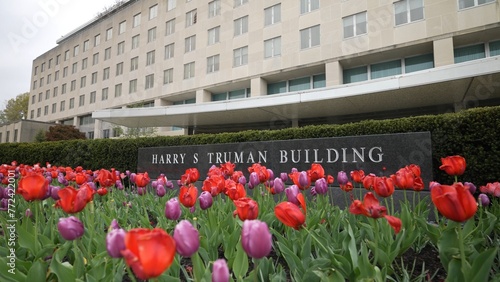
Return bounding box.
[55,184,94,213]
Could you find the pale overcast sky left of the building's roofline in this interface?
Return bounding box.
[0,0,116,109]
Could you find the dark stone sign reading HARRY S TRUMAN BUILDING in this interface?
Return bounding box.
[137,132,432,186]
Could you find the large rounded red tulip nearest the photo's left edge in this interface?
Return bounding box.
[17,172,49,201]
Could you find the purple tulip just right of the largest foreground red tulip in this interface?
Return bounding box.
[174,220,200,257]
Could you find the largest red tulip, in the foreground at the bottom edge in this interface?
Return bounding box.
[121,228,175,280]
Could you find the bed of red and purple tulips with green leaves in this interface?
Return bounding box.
[0,156,500,281]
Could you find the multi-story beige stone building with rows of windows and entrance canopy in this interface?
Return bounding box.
[29,0,500,138]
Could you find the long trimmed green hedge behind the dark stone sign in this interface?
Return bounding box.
[0,107,500,185]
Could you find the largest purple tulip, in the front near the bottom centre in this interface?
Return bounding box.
[241,219,272,259]
